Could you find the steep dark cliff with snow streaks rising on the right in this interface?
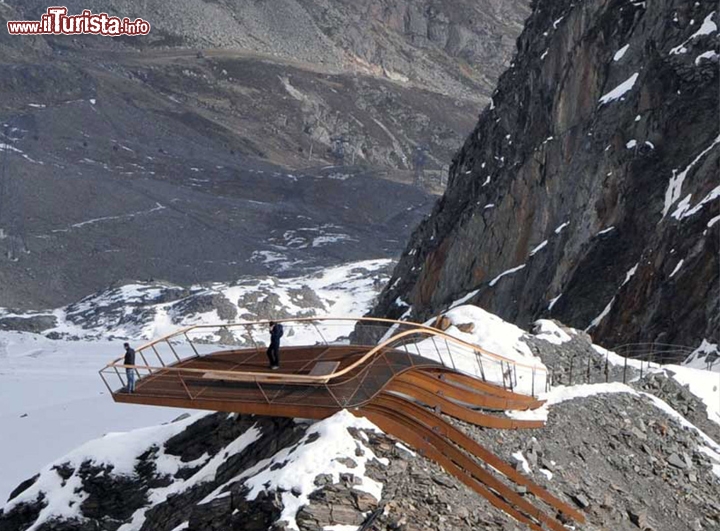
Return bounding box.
[374,0,720,352]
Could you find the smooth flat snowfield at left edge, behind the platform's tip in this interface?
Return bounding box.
[0,332,188,500]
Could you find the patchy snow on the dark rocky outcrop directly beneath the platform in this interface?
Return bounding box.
[4,411,386,531]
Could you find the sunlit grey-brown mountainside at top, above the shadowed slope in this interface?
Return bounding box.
[0,0,529,180]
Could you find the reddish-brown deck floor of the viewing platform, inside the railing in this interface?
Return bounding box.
[113,346,441,419]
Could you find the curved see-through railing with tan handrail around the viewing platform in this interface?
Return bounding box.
[100,318,549,407]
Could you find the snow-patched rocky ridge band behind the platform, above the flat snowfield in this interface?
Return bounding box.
[0,259,393,339]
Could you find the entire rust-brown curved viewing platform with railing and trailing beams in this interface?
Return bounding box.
[100,318,584,531]
